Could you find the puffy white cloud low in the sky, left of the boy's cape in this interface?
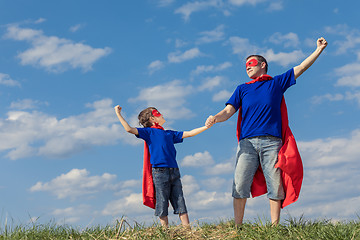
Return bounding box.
[30,169,116,200]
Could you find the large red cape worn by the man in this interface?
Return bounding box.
[236,74,303,208]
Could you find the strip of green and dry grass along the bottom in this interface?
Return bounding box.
[0,218,360,240]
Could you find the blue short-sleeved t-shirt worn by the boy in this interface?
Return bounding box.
[136,127,183,168]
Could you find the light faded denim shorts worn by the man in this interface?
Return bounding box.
[232,136,285,200]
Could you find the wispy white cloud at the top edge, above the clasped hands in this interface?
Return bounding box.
[175,0,222,21]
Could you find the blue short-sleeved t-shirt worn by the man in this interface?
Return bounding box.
[226,69,296,139]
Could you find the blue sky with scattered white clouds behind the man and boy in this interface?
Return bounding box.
[0,0,360,226]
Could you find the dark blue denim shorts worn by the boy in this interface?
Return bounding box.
[152,167,187,217]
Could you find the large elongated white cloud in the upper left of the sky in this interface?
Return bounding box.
[5,25,111,72]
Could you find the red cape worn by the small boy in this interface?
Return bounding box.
[142,124,164,209]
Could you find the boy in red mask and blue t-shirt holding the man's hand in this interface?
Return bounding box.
[115,105,208,227]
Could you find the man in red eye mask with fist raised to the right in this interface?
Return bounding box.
[205,37,327,226]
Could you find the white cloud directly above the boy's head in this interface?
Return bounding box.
[129,80,193,119]
